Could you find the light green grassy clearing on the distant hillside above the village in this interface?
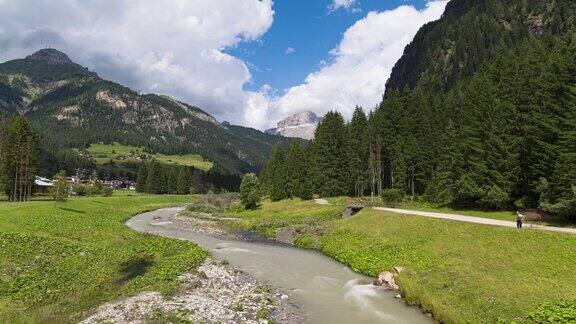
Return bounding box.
[86,143,213,171]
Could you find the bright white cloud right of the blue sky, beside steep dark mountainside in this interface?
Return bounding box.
[268,0,448,128]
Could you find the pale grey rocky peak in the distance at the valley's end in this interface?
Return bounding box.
[266,111,321,140]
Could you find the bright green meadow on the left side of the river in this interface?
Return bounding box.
[0,194,208,323]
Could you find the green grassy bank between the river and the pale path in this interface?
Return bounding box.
[227,200,576,323]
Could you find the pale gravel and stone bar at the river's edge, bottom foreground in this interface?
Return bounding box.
[82,260,304,324]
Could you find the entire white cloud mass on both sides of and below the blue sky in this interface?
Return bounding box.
[0,0,447,129]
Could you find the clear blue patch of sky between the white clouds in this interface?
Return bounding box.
[225,0,426,91]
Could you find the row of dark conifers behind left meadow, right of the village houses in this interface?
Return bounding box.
[136,161,241,195]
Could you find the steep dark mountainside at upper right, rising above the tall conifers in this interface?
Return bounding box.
[386,0,576,94]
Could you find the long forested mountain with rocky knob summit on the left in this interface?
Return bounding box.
[0,49,287,173]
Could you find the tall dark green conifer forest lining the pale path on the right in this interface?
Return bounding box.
[261,37,576,221]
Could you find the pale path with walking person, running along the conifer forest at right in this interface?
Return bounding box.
[374,207,576,234]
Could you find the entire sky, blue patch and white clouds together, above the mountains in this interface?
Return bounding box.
[0,0,447,129]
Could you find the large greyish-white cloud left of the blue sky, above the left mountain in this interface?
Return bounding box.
[0,0,274,126]
